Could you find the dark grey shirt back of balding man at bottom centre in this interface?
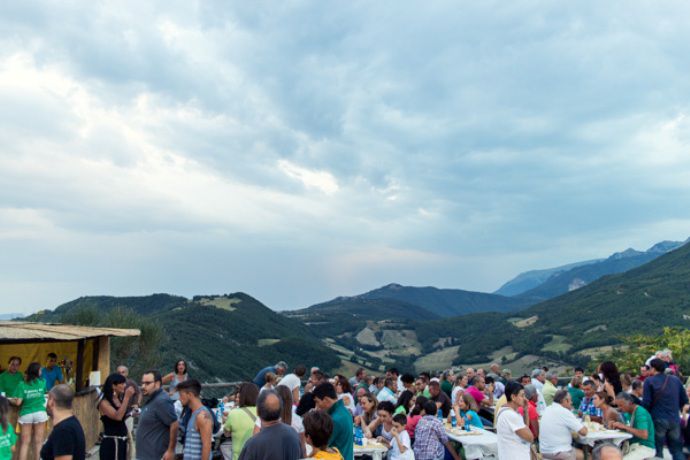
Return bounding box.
[239,423,302,460]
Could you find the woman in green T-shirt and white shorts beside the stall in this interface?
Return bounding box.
[12,363,48,460]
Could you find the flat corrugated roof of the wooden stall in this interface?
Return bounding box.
[0,321,141,342]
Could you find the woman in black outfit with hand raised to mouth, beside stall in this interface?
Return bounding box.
[97,373,134,460]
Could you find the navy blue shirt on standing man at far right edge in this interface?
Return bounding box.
[642,374,688,423]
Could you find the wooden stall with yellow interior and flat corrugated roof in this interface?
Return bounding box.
[0,321,140,449]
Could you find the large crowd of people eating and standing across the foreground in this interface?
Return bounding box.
[0,351,690,460]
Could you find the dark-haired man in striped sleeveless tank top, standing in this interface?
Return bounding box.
[177,379,213,460]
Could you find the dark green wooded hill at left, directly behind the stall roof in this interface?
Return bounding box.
[29,293,340,381]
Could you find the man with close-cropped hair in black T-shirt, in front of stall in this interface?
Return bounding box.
[41,384,86,460]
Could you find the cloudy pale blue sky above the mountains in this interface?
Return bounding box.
[0,0,690,313]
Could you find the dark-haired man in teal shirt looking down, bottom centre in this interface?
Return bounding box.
[313,382,352,460]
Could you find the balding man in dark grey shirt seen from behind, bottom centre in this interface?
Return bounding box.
[238,389,300,460]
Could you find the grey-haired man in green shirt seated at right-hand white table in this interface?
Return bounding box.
[611,392,656,460]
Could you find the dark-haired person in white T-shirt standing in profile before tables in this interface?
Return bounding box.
[496,382,534,460]
